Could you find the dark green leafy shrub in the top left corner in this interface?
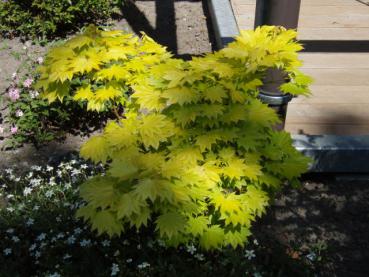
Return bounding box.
[0,0,122,39]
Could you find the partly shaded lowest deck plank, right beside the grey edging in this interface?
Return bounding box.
[285,123,369,135]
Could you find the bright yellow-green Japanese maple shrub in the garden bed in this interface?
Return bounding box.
[37,26,311,249]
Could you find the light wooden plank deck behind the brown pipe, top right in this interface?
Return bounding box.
[231,0,369,135]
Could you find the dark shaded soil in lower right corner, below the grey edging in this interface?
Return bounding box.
[256,174,369,277]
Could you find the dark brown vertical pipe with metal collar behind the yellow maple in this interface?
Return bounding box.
[255,0,301,125]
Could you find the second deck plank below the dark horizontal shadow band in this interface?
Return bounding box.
[303,68,369,86]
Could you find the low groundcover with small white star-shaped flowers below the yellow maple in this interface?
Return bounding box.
[0,155,321,277]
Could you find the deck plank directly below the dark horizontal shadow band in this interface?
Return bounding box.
[299,53,369,69]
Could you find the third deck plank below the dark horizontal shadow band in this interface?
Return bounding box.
[291,85,369,103]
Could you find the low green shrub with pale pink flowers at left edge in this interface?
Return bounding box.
[0,43,113,148]
